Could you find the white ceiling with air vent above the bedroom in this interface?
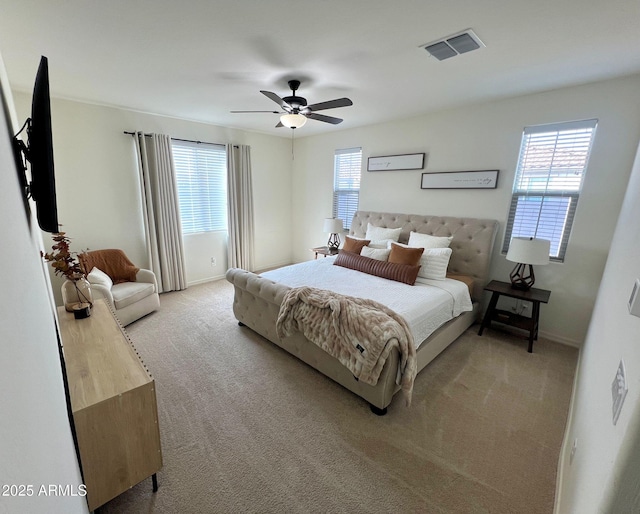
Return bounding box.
[0,0,640,137]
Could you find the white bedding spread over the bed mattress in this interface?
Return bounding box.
[261,257,473,348]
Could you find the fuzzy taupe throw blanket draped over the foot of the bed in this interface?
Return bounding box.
[276,287,417,405]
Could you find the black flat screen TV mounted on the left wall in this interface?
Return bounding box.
[14,56,59,233]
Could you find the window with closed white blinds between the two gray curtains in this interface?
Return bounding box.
[171,141,227,234]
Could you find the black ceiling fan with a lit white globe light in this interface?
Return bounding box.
[231,80,353,129]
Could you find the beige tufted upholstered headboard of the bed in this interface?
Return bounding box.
[349,211,498,300]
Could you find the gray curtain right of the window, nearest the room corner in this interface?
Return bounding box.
[227,144,254,271]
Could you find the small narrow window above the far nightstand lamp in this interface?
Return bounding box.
[333,148,362,230]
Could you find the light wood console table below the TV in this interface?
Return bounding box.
[58,300,162,510]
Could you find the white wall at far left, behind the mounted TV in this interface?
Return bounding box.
[0,52,88,513]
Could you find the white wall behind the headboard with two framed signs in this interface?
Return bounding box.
[293,75,640,345]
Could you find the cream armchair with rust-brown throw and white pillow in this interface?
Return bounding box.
[78,250,160,326]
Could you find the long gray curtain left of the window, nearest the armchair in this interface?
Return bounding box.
[134,132,187,293]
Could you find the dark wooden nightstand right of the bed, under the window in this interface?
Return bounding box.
[478,280,551,353]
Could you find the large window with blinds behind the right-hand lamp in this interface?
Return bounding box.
[502,120,597,261]
